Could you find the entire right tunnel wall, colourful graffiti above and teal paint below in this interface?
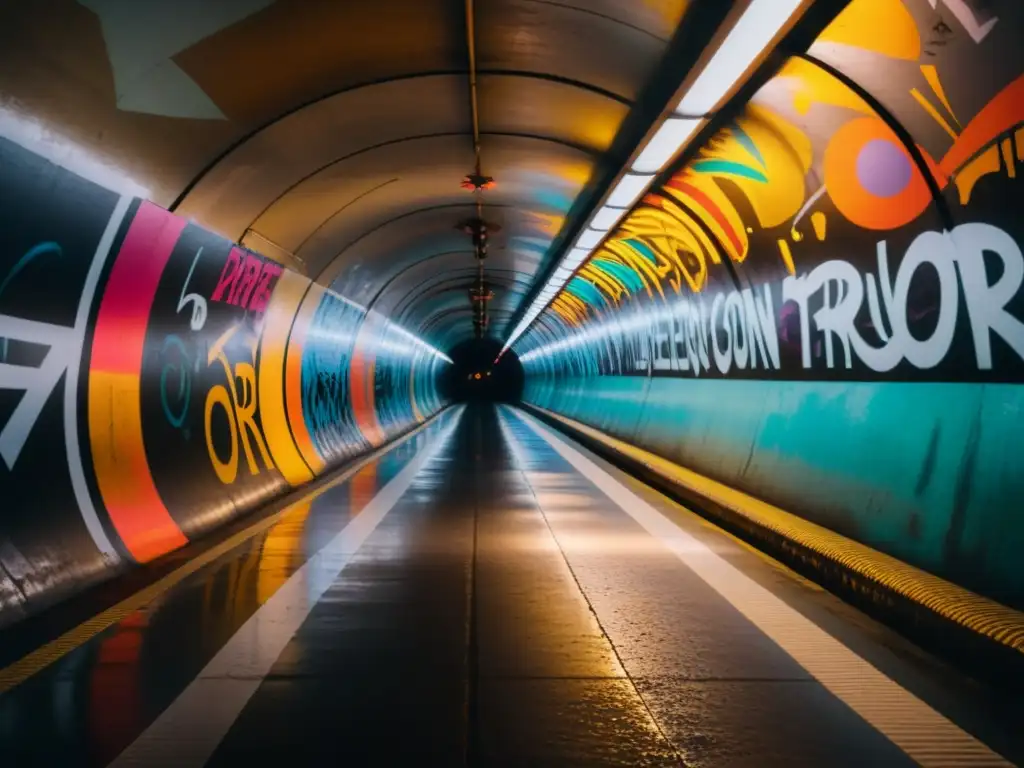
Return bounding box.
[516,0,1024,607]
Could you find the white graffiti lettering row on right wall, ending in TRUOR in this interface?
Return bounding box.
[522,222,1024,378]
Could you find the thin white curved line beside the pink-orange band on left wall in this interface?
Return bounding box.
[63,196,132,565]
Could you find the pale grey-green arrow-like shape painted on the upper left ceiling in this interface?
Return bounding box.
[79,0,273,120]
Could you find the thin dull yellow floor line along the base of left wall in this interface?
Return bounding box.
[0,411,444,694]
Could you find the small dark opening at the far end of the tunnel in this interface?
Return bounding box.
[438,338,524,402]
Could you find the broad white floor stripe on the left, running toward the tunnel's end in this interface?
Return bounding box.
[110,409,463,768]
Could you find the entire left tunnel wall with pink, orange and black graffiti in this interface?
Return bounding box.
[0,139,444,625]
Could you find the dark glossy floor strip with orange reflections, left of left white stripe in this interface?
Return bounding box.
[0,417,448,766]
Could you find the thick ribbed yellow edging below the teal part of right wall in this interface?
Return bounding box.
[530,406,1024,653]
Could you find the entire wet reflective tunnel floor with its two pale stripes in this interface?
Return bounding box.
[0,407,1024,768]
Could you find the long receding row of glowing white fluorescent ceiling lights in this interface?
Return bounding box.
[499,0,810,357]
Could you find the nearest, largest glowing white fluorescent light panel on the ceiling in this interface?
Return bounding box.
[676,0,804,115]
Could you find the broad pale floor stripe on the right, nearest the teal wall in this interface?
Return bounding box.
[514,411,1013,768]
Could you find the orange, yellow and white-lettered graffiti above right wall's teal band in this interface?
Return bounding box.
[517,0,1024,381]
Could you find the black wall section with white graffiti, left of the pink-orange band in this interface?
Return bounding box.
[0,139,129,616]
